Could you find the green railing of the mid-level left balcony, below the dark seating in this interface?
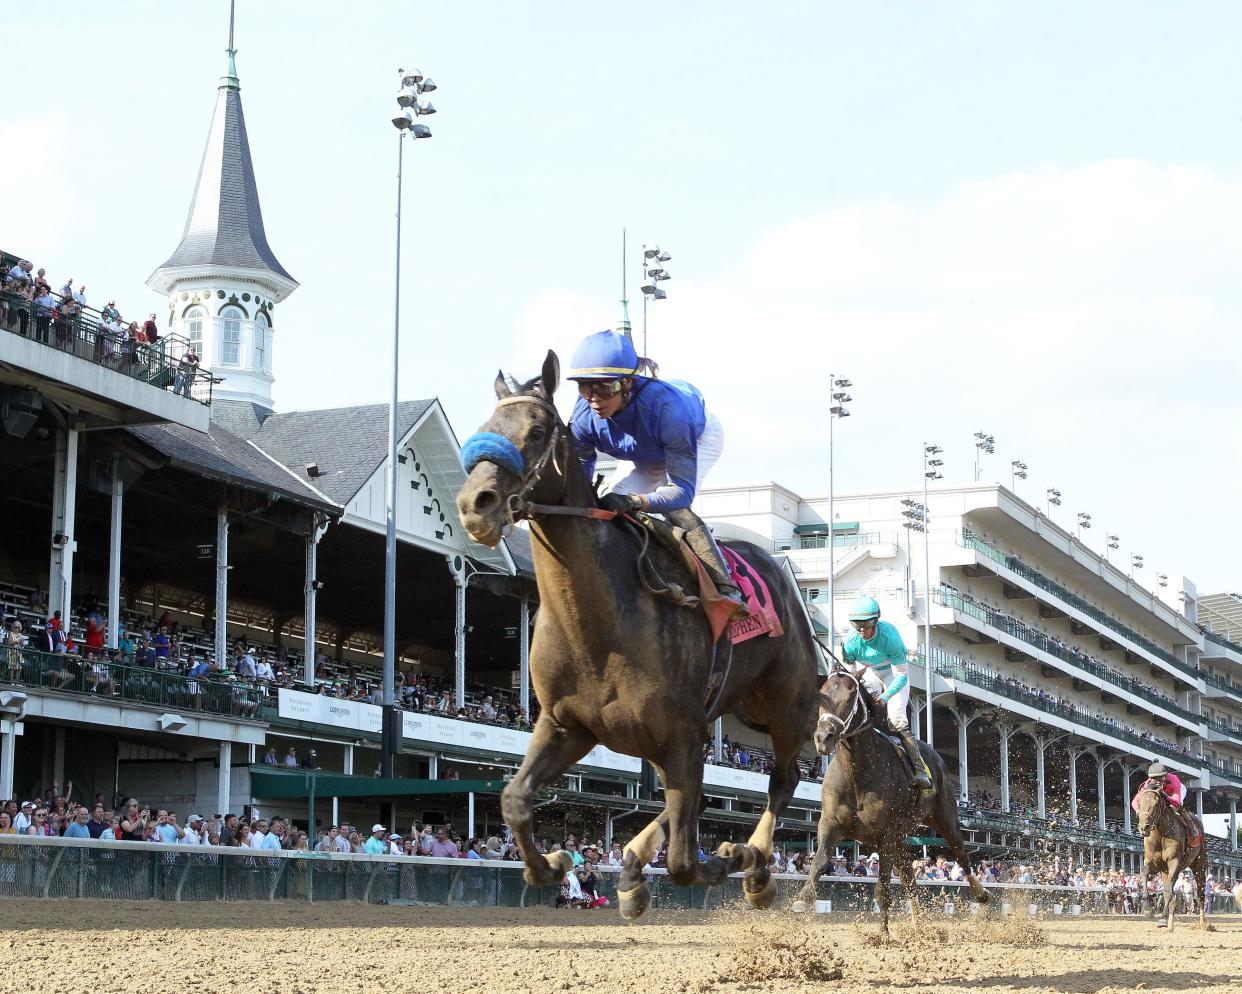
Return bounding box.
[0,647,263,721]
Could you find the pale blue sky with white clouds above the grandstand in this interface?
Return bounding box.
[7,0,1242,590]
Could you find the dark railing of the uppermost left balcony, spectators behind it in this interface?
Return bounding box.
[0,273,214,405]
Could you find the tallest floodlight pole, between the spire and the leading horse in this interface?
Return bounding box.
[380,70,436,777]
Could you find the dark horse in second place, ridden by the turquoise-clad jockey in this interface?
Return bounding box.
[794,668,989,934]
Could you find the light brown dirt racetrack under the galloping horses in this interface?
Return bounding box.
[0,901,1242,994]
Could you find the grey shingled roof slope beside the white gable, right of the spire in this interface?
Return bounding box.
[253,400,436,506]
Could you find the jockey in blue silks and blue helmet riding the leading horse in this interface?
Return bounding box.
[569,332,746,618]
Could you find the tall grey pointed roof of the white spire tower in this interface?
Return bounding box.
[148,53,297,292]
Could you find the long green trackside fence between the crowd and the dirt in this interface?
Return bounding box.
[0,836,1142,914]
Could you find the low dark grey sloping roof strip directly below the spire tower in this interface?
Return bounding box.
[128,424,340,514]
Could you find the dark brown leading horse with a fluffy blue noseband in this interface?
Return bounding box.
[457,352,818,918]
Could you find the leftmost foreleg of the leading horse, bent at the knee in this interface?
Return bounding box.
[501,711,596,887]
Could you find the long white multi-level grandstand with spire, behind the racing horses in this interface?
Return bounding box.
[0,17,1242,878]
